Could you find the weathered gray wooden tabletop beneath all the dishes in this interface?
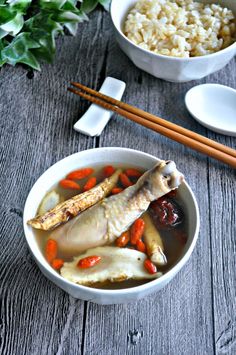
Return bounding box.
[0,10,236,355]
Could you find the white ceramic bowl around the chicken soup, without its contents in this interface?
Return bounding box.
[24,148,199,304]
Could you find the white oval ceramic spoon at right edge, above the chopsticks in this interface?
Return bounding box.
[185,84,236,137]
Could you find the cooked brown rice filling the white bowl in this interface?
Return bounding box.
[124,0,236,57]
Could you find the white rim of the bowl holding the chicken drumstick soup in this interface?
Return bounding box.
[23,147,200,296]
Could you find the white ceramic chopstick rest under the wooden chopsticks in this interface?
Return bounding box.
[74,76,126,137]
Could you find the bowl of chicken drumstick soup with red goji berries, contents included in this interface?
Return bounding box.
[24,148,199,304]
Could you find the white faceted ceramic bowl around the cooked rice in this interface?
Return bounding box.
[110,0,236,82]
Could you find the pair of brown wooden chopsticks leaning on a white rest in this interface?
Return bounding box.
[68,82,236,168]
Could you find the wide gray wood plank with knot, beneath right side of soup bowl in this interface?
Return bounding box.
[81,11,221,354]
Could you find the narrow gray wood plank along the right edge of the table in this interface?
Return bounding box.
[207,60,236,355]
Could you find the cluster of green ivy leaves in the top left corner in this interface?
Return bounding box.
[0,0,110,70]
